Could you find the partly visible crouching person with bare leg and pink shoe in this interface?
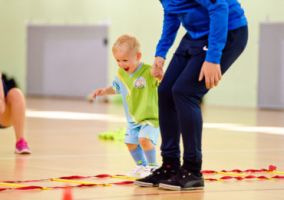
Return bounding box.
[0,72,31,154]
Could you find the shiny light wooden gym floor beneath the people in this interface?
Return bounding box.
[0,98,284,200]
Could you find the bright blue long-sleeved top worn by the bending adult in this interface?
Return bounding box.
[155,0,247,64]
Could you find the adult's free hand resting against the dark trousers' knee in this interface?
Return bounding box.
[198,61,222,89]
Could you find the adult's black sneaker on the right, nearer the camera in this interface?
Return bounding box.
[159,168,204,190]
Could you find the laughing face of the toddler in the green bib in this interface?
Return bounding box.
[113,48,141,74]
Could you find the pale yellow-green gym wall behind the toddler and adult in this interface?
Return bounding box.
[0,0,284,107]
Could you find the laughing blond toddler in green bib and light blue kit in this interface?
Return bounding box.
[90,35,162,177]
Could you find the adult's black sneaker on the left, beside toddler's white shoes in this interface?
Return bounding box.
[134,165,177,187]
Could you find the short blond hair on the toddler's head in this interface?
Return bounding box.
[112,34,140,53]
